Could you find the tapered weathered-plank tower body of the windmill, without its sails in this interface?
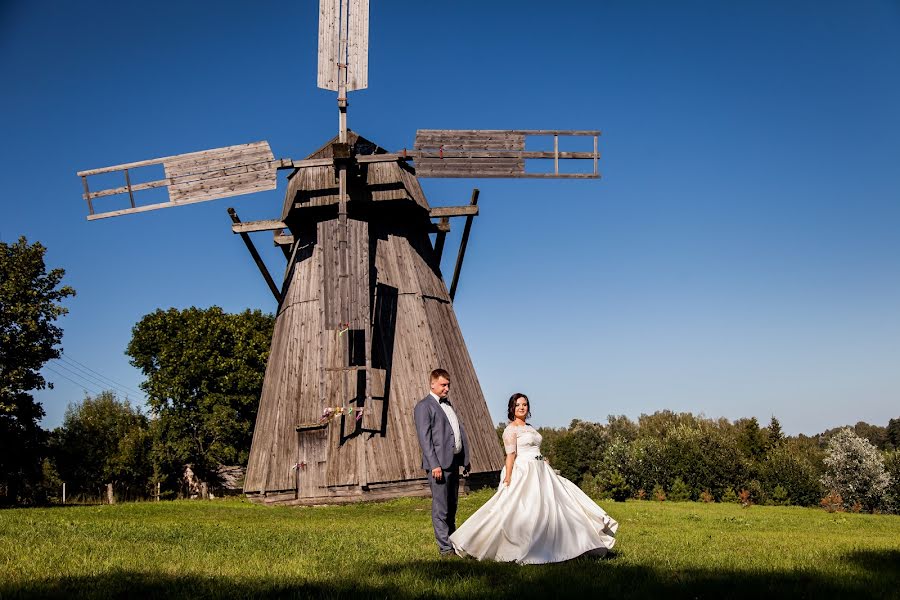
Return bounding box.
[244,135,503,504]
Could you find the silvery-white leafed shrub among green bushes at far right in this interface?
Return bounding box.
[822,427,891,510]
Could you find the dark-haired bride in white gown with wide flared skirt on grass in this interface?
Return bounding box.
[450,394,619,564]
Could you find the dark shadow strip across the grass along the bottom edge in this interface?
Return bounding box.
[0,550,900,600]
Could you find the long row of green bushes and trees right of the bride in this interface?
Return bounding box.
[520,410,900,513]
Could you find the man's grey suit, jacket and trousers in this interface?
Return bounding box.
[414,394,470,554]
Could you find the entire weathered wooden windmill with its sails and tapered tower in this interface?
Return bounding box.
[78,0,599,504]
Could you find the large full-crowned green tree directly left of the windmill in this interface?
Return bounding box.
[126,306,275,483]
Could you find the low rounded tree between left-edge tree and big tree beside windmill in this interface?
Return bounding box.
[54,391,152,497]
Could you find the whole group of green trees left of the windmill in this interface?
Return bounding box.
[0,237,274,505]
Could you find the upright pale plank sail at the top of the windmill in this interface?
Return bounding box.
[316,0,369,92]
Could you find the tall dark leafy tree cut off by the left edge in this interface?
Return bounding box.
[0,236,75,503]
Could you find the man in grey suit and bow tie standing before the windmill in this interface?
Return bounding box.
[415,369,470,556]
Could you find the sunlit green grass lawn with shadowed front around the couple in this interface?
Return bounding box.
[0,491,900,600]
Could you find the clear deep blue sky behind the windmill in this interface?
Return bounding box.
[0,0,900,433]
